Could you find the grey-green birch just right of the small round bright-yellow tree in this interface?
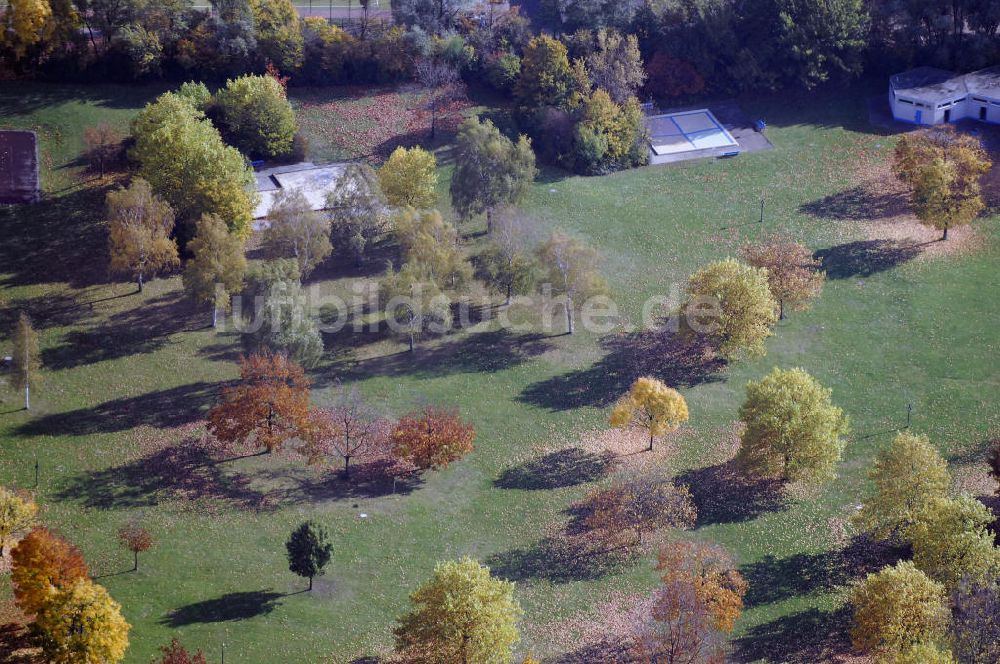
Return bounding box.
[451,118,538,232]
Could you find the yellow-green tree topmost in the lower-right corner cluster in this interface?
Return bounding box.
[855,431,951,539]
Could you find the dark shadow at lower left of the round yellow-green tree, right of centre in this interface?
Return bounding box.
[677,460,786,527]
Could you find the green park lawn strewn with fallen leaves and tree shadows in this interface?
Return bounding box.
[0,84,1000,664]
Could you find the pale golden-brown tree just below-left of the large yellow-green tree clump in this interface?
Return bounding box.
[107,178,180,293]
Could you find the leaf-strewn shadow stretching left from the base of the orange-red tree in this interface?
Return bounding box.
[56,439,271,511]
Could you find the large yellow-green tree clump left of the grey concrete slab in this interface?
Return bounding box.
[132,92,257,239]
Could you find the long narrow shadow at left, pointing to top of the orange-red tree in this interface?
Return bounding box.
[16,382,222,436]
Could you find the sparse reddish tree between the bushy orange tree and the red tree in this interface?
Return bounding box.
[302,386,384,479]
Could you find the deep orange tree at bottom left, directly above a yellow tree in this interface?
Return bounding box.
[10,528,90,615]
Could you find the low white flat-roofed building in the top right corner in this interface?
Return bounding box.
[889,67,1000,125]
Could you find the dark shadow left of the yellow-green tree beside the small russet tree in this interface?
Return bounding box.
[520,330,726,411]
